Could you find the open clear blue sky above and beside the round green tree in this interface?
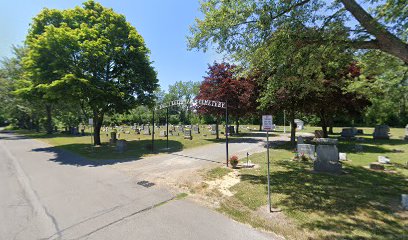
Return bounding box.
[0,0,222,90]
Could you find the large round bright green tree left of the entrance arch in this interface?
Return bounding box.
[21,1,158,145]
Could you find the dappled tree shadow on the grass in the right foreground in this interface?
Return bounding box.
[241,161,408,239]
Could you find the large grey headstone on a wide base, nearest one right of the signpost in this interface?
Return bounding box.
[313,138,342,174]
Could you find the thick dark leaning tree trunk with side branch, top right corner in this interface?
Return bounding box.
[340,0,408,64]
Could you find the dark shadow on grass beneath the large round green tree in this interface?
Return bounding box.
[33,139,183,167]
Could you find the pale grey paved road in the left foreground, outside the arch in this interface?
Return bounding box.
[0,133,275,240]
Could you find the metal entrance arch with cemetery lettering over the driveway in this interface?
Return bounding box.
[152,99,229,167]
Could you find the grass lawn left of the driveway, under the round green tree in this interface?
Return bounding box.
[12,126,253,161]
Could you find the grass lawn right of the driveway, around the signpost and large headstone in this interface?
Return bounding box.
[219,127,408,239]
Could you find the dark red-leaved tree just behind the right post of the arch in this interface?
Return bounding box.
[197,63,256,138]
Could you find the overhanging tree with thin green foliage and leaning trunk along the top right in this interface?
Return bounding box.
[188,0,408,63]
